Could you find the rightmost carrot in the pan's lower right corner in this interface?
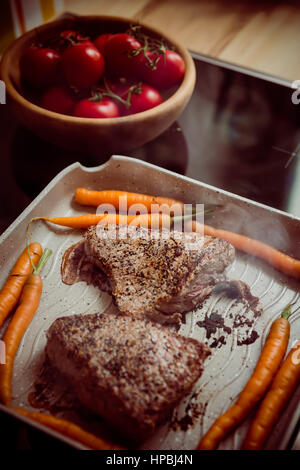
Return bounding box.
[243,341,300,450]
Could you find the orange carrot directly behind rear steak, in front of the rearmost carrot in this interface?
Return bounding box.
[30,213,171,229]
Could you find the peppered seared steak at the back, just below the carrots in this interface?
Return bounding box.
[62,225,235,323]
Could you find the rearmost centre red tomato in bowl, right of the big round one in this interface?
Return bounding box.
[104,33,142,77]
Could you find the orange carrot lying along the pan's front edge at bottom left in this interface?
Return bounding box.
[14,408,124,450]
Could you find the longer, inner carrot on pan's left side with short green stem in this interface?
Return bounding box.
[0,250,51,406]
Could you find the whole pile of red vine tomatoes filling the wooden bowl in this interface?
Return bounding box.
[20,25,185,118]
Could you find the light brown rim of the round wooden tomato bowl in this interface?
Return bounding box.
[0,15,196,127]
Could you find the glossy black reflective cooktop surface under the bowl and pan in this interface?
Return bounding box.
[0,56,300,447]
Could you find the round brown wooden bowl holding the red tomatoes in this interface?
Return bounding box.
[0,16,196,155]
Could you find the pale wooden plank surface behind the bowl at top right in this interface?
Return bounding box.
[64,0,300,81]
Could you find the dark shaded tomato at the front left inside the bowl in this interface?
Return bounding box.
[41,85,76,114]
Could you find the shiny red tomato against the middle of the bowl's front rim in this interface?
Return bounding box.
[73,96,120,118]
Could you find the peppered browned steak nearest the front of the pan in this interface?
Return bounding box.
[46,314,210,440]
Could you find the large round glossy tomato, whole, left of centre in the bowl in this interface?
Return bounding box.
[62,41,105,88]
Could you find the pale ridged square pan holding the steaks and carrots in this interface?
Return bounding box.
[0,156,300,450]
